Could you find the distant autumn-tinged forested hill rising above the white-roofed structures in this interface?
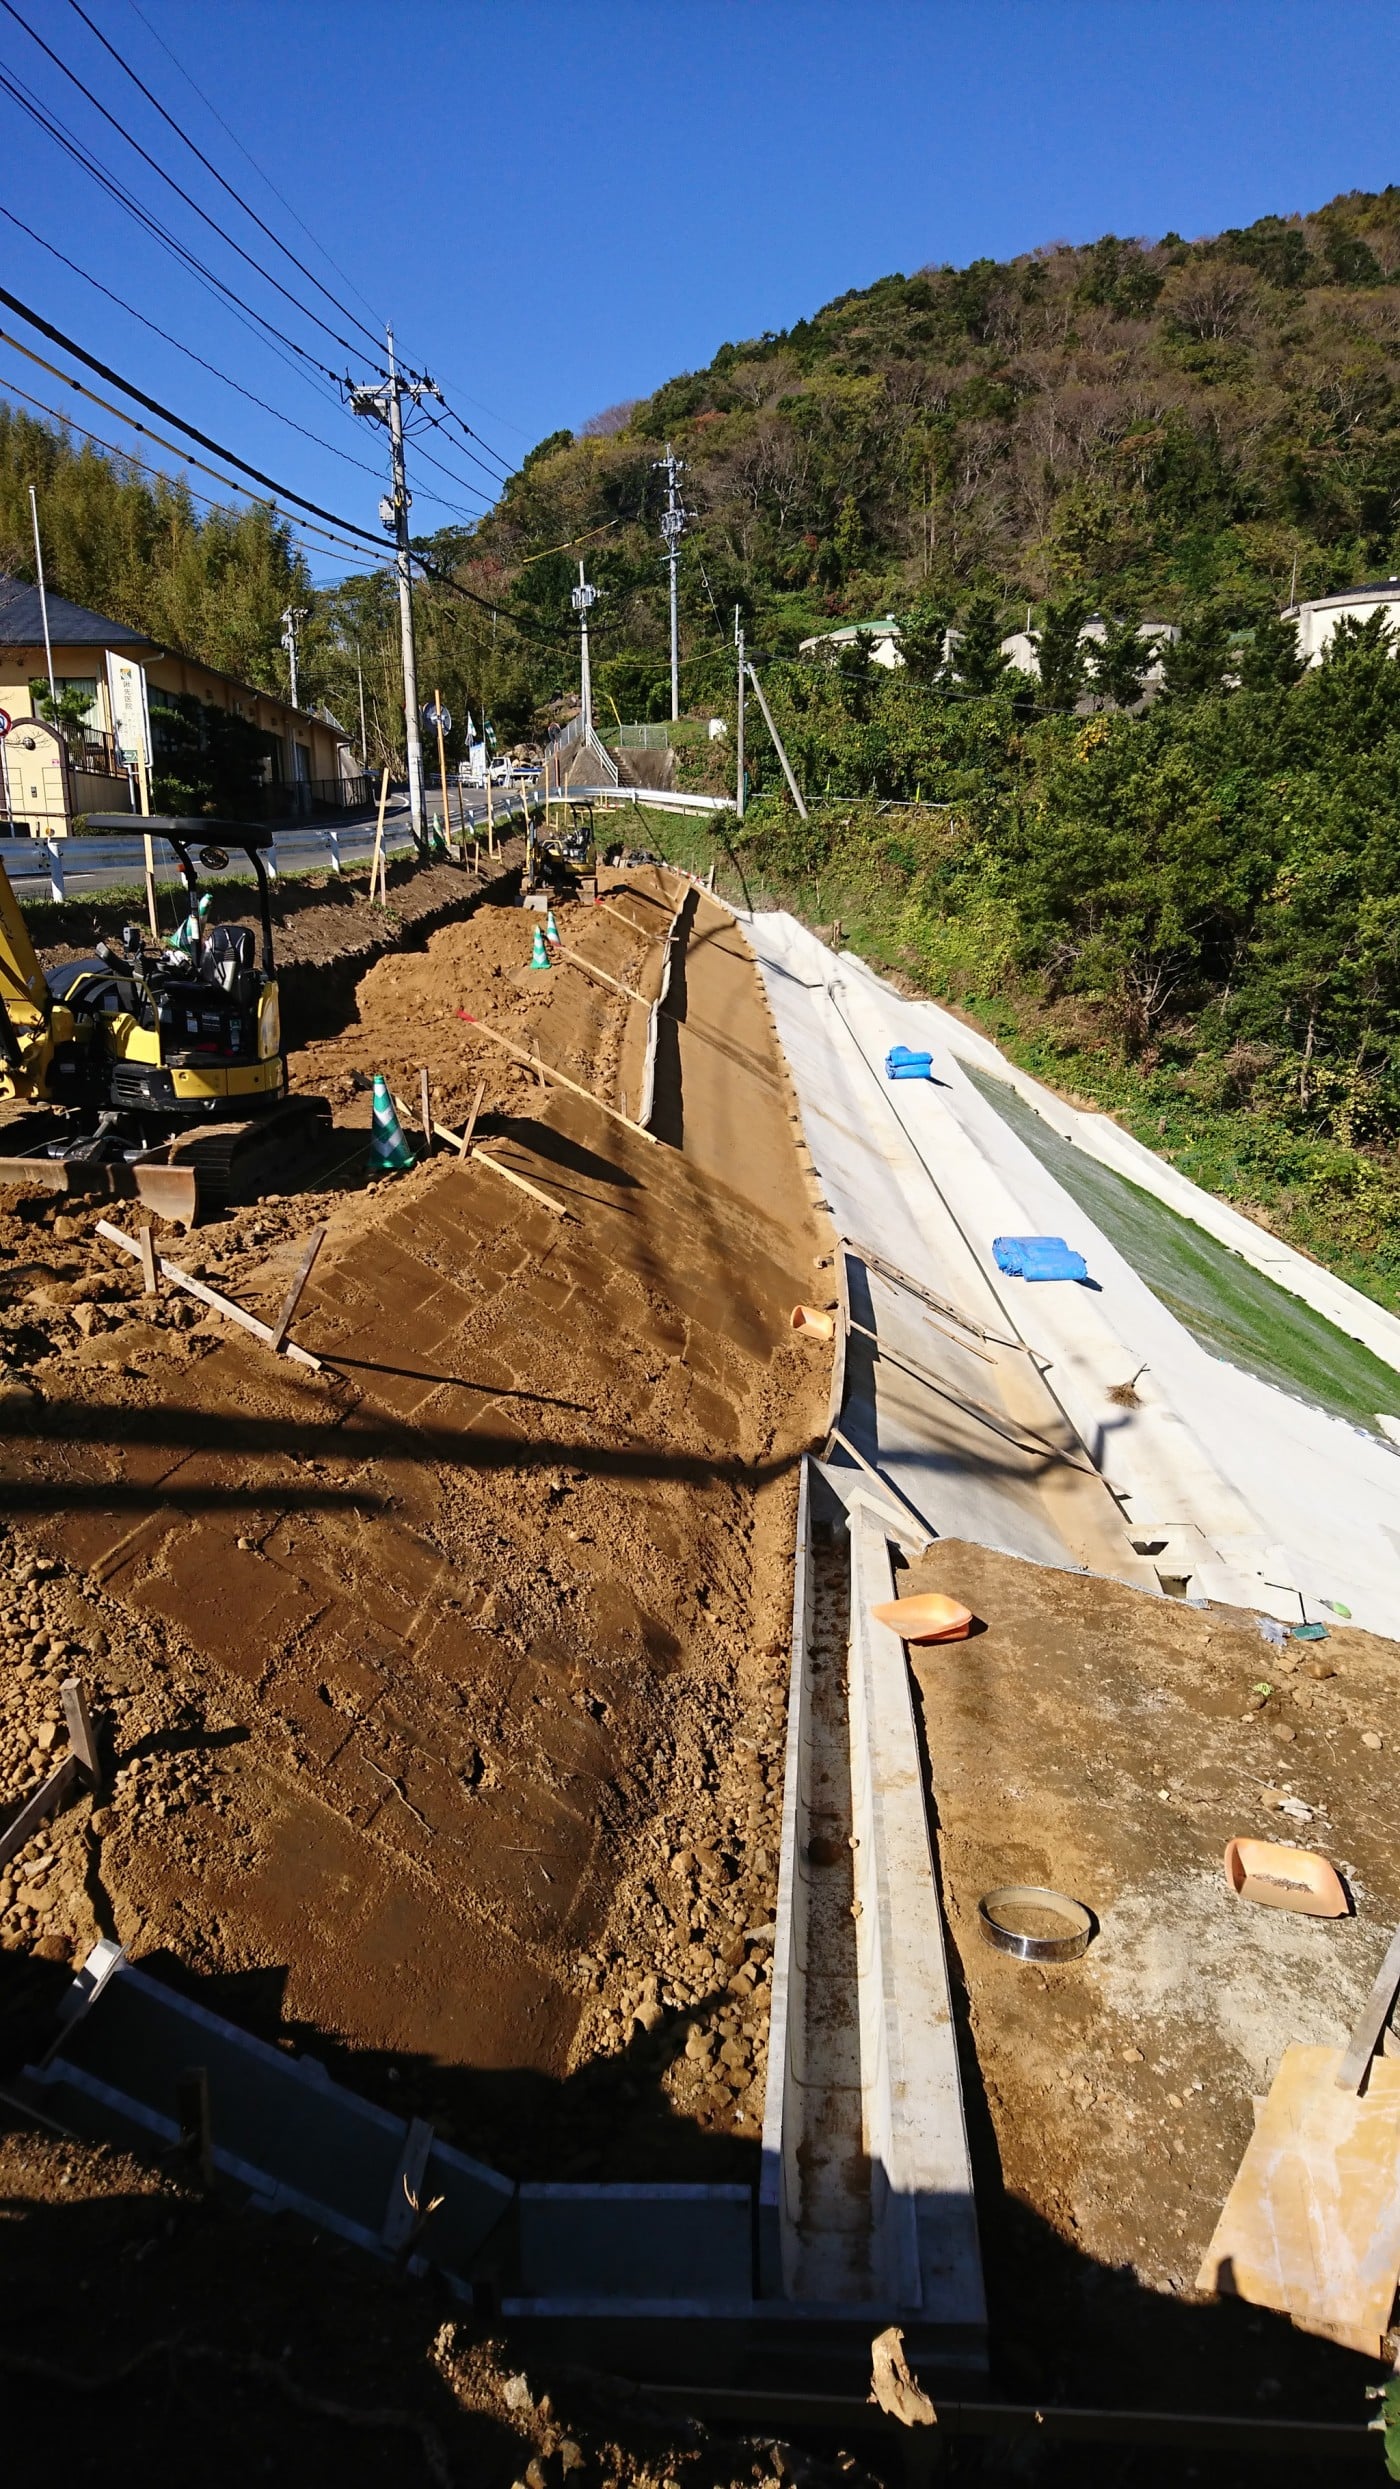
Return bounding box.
[460,189,1400,714]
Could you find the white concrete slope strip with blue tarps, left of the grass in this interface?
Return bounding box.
[745,913,1400,1638]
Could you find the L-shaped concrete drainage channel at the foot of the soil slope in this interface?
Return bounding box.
[22,1461,986,2387]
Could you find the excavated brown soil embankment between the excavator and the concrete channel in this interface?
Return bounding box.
[0,866,825,2175]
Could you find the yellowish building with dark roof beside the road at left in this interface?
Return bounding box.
[0,577,364,839]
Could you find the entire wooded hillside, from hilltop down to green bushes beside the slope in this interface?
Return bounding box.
[440,189,1400,1299]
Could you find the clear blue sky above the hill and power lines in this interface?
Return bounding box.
[0,0,1400,577]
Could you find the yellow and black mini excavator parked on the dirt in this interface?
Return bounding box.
[0,814,331,1227]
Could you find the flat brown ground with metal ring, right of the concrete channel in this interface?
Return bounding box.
[899,1541,1400,2419]
